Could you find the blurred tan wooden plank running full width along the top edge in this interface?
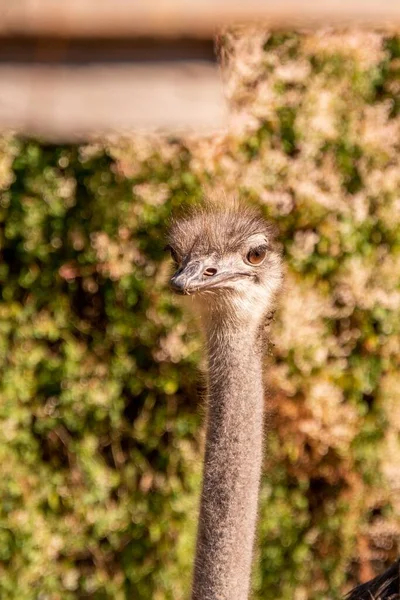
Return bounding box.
[0,0,400,38]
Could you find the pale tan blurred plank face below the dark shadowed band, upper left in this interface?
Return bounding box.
[0,61,227,141]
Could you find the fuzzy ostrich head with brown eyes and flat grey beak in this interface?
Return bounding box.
[168,199,282,323]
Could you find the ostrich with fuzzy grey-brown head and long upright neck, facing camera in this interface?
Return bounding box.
[167,199,400,600]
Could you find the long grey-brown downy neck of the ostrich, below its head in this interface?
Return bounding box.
[192,324,264,600]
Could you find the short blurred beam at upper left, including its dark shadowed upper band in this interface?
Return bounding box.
[0,37,228,141]
